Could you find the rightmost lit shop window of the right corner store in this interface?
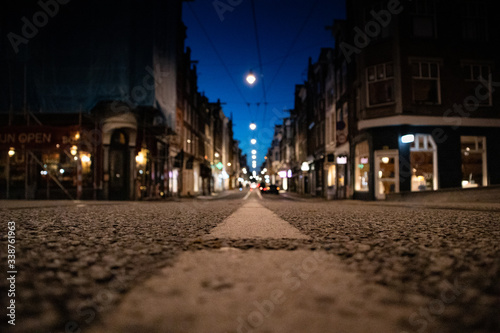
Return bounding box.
[460,136,488,188]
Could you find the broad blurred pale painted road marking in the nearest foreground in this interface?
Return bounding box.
[89,248,432,333]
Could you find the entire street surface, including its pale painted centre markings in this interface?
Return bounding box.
[0,191,500,332]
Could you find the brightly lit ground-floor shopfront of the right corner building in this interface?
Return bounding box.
[352,126,500,200]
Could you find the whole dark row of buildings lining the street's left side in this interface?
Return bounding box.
[0,0,242,200]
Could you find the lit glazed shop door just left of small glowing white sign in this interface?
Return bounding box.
[375,149,399,200]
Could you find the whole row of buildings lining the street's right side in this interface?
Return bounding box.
[266,0,500,200]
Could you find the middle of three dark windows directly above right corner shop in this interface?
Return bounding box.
[411,62,441,104]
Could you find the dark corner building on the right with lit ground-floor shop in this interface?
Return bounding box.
[348,0,500,199]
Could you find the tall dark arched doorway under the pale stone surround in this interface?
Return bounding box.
[109,130,130,200]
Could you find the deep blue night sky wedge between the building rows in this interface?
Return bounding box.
[183,0,345,166]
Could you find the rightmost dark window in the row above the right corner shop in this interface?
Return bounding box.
[462,64,493,106]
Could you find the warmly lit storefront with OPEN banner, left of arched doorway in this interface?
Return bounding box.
[0,125,96,199]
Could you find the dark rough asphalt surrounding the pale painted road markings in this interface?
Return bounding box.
[0,192,500,333]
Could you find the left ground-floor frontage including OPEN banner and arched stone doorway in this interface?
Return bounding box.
[0,110,176,200]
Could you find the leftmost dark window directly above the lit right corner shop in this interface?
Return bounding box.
[366,63,394,105]
